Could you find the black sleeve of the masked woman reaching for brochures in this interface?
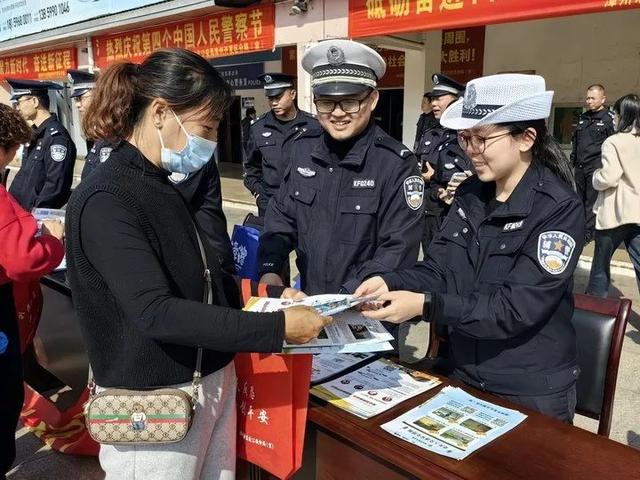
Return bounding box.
[80,192,284,352]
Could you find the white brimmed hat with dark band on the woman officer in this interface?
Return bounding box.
[440,73,553,130]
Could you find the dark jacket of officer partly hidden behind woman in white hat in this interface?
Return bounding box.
[416,123,474,216]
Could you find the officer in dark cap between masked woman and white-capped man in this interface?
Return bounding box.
[244,73,318,217]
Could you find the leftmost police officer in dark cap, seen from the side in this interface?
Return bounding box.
[7,79,76,210]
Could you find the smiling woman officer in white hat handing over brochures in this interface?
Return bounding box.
[356,74,584,422]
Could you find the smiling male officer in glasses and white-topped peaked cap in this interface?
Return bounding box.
[258,40,424,294]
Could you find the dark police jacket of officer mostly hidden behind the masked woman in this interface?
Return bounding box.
[82,140,235,273]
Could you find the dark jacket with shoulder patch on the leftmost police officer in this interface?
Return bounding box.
[9,114,76,211]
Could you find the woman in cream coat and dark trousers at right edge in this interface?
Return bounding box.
[587,94,640,297]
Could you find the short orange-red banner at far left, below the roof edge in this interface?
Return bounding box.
[0,47,78,80]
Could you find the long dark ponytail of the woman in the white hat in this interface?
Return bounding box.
[500,119,576,190]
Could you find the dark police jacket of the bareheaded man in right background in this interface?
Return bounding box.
[571,108,615,171]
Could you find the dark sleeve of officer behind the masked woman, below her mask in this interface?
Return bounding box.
[193,159,235,273]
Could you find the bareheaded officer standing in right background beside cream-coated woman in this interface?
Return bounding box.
[571,84,615,243]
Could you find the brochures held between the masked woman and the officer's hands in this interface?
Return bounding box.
[245,295,393,353]
